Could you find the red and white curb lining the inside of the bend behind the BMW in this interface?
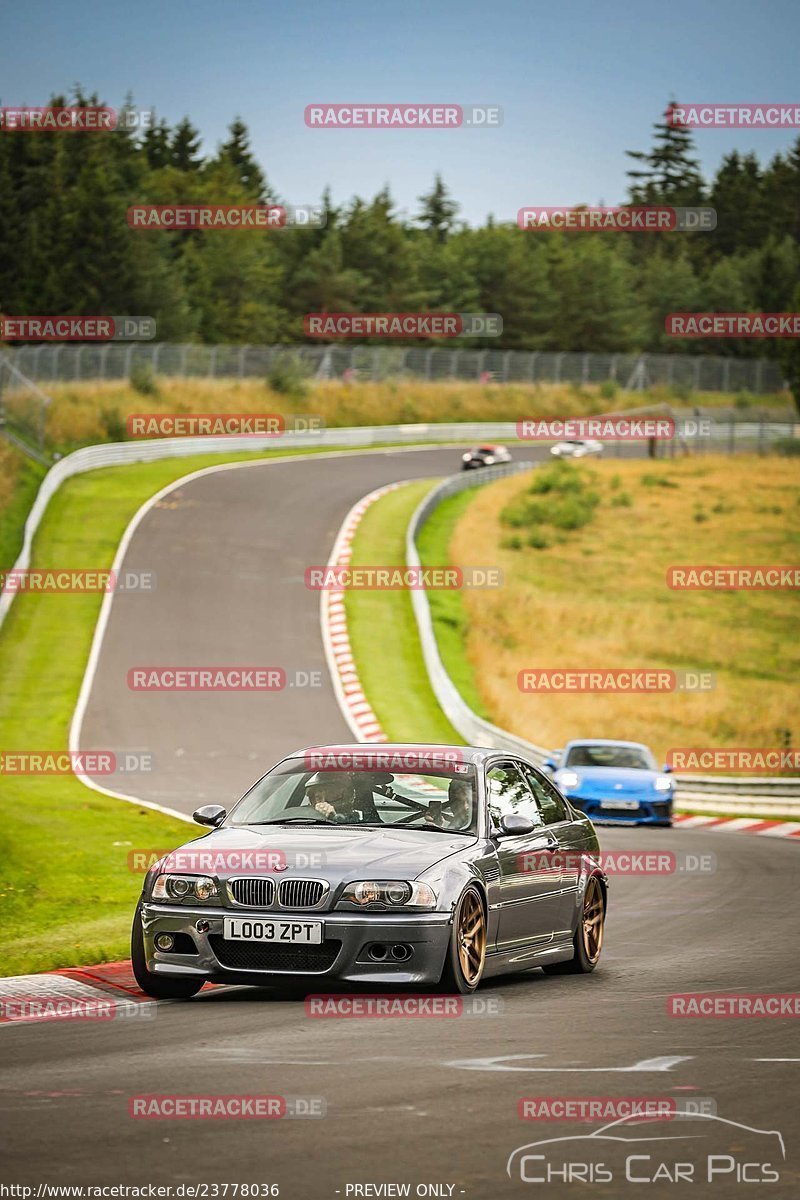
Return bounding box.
[320,480,408,742]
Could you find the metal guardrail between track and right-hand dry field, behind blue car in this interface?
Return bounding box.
[405,462,800,818]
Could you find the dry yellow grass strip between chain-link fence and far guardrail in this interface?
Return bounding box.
[8,378,767,446]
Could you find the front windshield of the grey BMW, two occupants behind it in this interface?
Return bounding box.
[225,762,477,834]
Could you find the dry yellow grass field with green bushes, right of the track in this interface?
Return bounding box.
[450,457,800,760]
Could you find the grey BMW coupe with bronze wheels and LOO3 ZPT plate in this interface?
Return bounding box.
[131,744,608,998]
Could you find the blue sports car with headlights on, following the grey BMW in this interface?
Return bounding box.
[545,738,675,826]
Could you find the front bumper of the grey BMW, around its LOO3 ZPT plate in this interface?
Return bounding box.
[140,902,452,985]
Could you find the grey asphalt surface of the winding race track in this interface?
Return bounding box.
[0,450,800,1200]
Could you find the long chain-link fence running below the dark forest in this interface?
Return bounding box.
[1,342,784,394]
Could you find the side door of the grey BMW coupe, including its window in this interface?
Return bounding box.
[486,758,560,950]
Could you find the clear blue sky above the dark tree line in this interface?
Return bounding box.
[0,0,800,224]
